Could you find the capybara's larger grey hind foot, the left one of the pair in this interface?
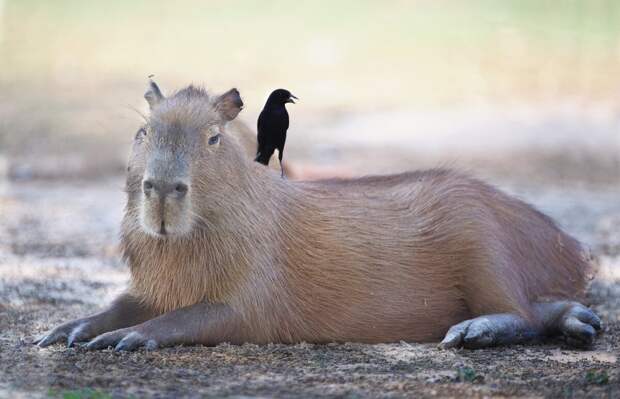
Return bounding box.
[439,313,538,349]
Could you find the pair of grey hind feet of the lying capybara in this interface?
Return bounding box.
[440,301,601,349]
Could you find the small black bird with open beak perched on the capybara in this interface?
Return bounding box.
[254,89,298,177]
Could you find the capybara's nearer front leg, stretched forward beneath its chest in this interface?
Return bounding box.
[87,303,242,351]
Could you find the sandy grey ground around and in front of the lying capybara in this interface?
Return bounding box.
[0,173,620,398]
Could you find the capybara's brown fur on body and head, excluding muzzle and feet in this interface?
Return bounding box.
[117,83,591,343]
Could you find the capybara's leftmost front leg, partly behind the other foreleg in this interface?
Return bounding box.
[33,294,156,348]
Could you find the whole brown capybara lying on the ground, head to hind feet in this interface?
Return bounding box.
[36,82,600,350]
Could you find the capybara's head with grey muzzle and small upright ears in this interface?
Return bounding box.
[127,81,243,238]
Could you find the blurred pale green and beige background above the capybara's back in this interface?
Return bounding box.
[0,0,620,184]
